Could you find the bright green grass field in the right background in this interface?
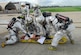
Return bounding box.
[41,7,81,12]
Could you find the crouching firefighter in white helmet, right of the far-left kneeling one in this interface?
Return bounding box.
[25,17,37,33]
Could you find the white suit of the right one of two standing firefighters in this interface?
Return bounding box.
[34,7,46,36]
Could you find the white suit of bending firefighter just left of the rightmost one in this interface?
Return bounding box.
[46,16,58,35]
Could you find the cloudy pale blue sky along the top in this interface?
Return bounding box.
[0,0,81,6]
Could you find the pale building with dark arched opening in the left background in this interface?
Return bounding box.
[0,2,30,13]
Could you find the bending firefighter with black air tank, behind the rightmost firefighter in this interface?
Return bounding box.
[43,12,55,38]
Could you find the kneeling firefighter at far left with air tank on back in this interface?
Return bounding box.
[1,17,29,47]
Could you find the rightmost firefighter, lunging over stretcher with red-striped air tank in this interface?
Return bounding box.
[49,14,75,50]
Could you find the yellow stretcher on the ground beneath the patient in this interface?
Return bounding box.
[20,36,67,44]
